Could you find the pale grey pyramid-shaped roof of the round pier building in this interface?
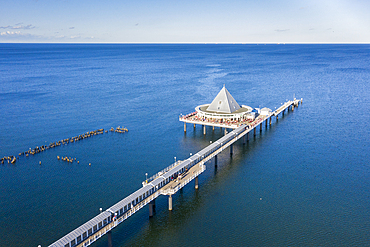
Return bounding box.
[207,85,240,113]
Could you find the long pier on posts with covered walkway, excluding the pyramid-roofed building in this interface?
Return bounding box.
[49,96,302,247]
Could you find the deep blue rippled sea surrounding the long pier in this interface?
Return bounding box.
[0,44,370,247]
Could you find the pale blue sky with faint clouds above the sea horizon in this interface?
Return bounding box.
[0,0,370,43]
